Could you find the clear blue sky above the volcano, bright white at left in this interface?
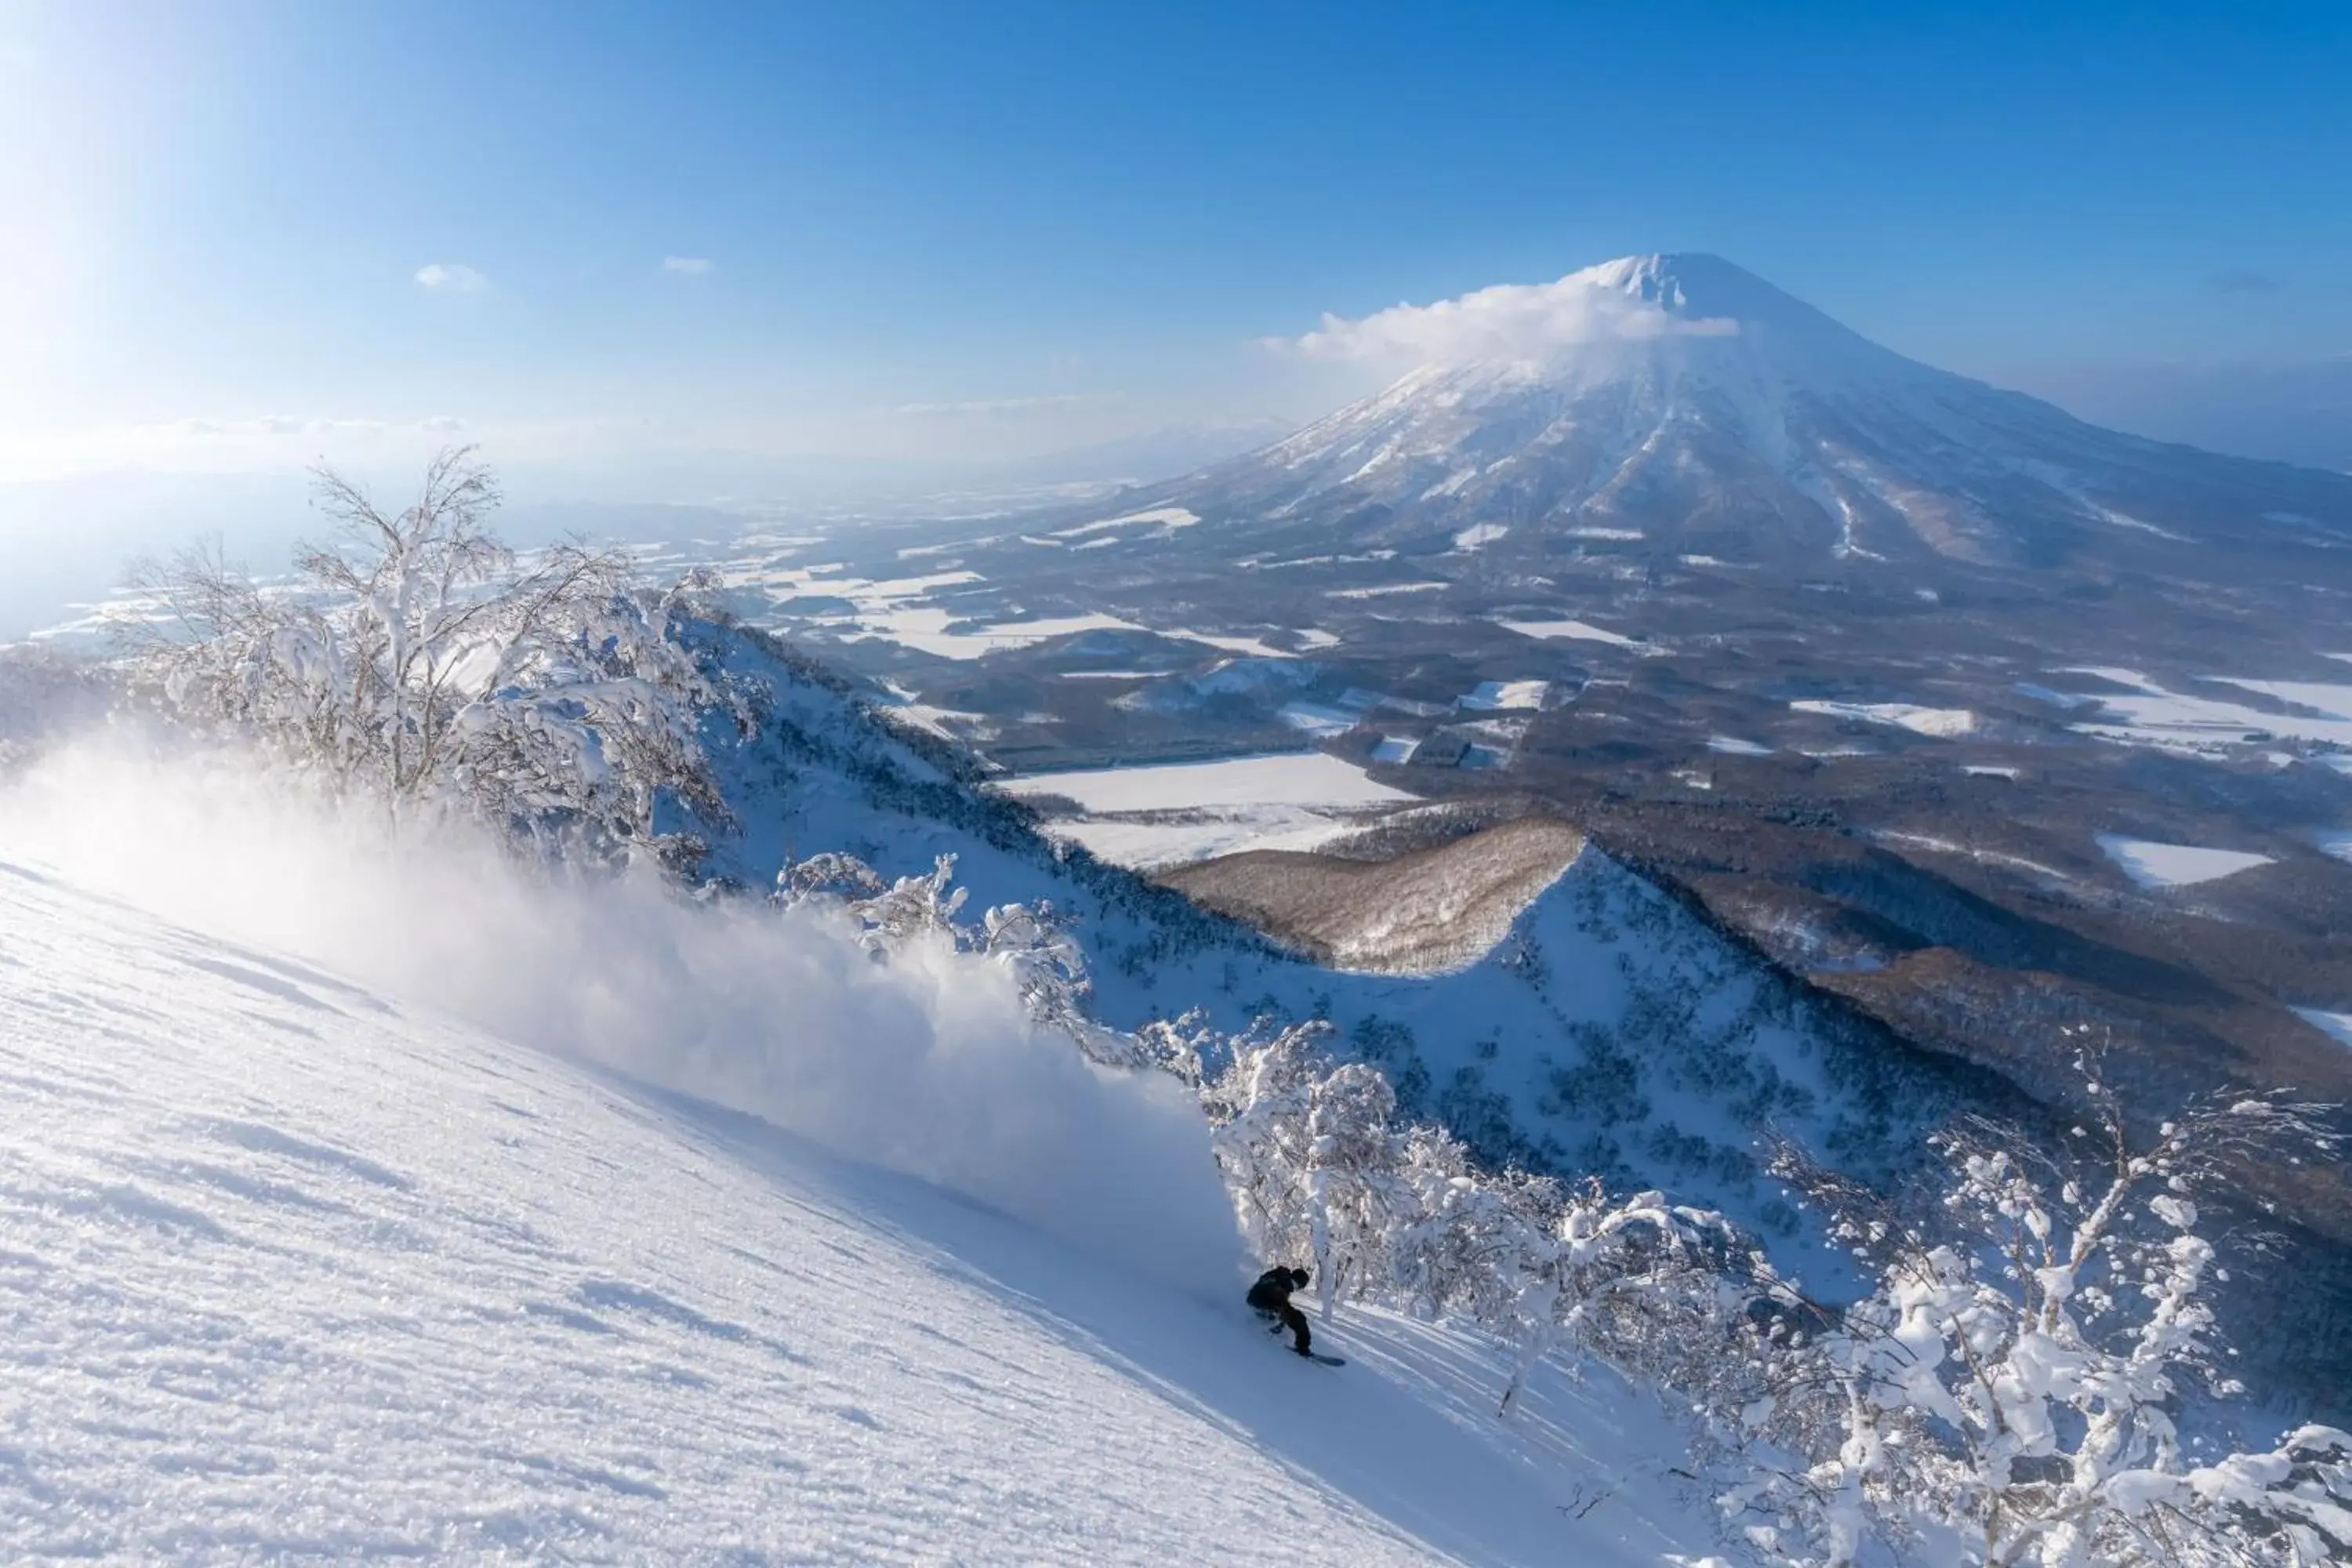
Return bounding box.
[0,0,2352,480]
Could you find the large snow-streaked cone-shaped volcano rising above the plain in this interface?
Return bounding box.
[1167,256,2352,567]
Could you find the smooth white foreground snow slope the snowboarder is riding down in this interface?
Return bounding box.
[0,858,1710,1563]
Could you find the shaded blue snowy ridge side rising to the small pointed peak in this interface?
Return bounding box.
[687,633,1955,1234]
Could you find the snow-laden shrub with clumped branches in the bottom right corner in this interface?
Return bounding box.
[1729,1044,2352,1568]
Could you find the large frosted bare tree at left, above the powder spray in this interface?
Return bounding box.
[129,449,748,851]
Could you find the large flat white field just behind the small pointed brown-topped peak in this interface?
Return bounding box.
[995,752,1418,869]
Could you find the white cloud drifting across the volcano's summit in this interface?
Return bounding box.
[1268,273,1738,365]
